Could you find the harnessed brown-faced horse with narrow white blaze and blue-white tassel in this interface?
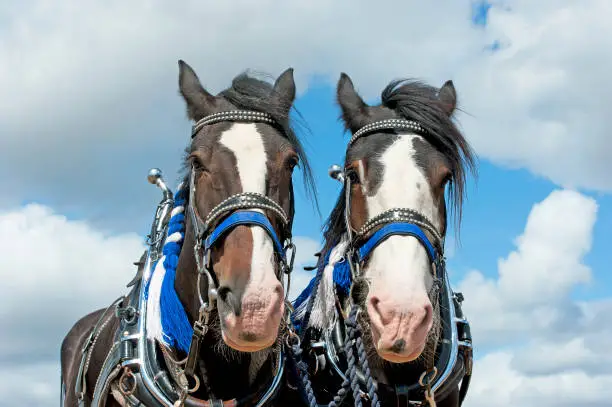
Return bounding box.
[61,61,316,407]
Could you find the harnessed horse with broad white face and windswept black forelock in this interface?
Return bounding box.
[290,74,475,407]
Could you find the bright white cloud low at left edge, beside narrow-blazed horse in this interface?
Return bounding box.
[0,204,144,363]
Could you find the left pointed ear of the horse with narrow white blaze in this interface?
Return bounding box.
[179,60,216,121]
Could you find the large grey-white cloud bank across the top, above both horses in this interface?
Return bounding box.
[0,0,612,236]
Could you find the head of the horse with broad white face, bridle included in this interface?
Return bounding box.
[328,74,473,363]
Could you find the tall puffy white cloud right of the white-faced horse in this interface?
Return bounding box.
[459,190,597,342]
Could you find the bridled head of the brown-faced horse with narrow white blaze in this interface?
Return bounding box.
[176,61,308,352]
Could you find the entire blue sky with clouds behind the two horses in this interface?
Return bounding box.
[0,0,612,407]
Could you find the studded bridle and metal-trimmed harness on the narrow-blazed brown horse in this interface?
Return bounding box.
[73,111,295,407]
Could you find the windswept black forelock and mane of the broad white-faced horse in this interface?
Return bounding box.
[321,79,476,259]
